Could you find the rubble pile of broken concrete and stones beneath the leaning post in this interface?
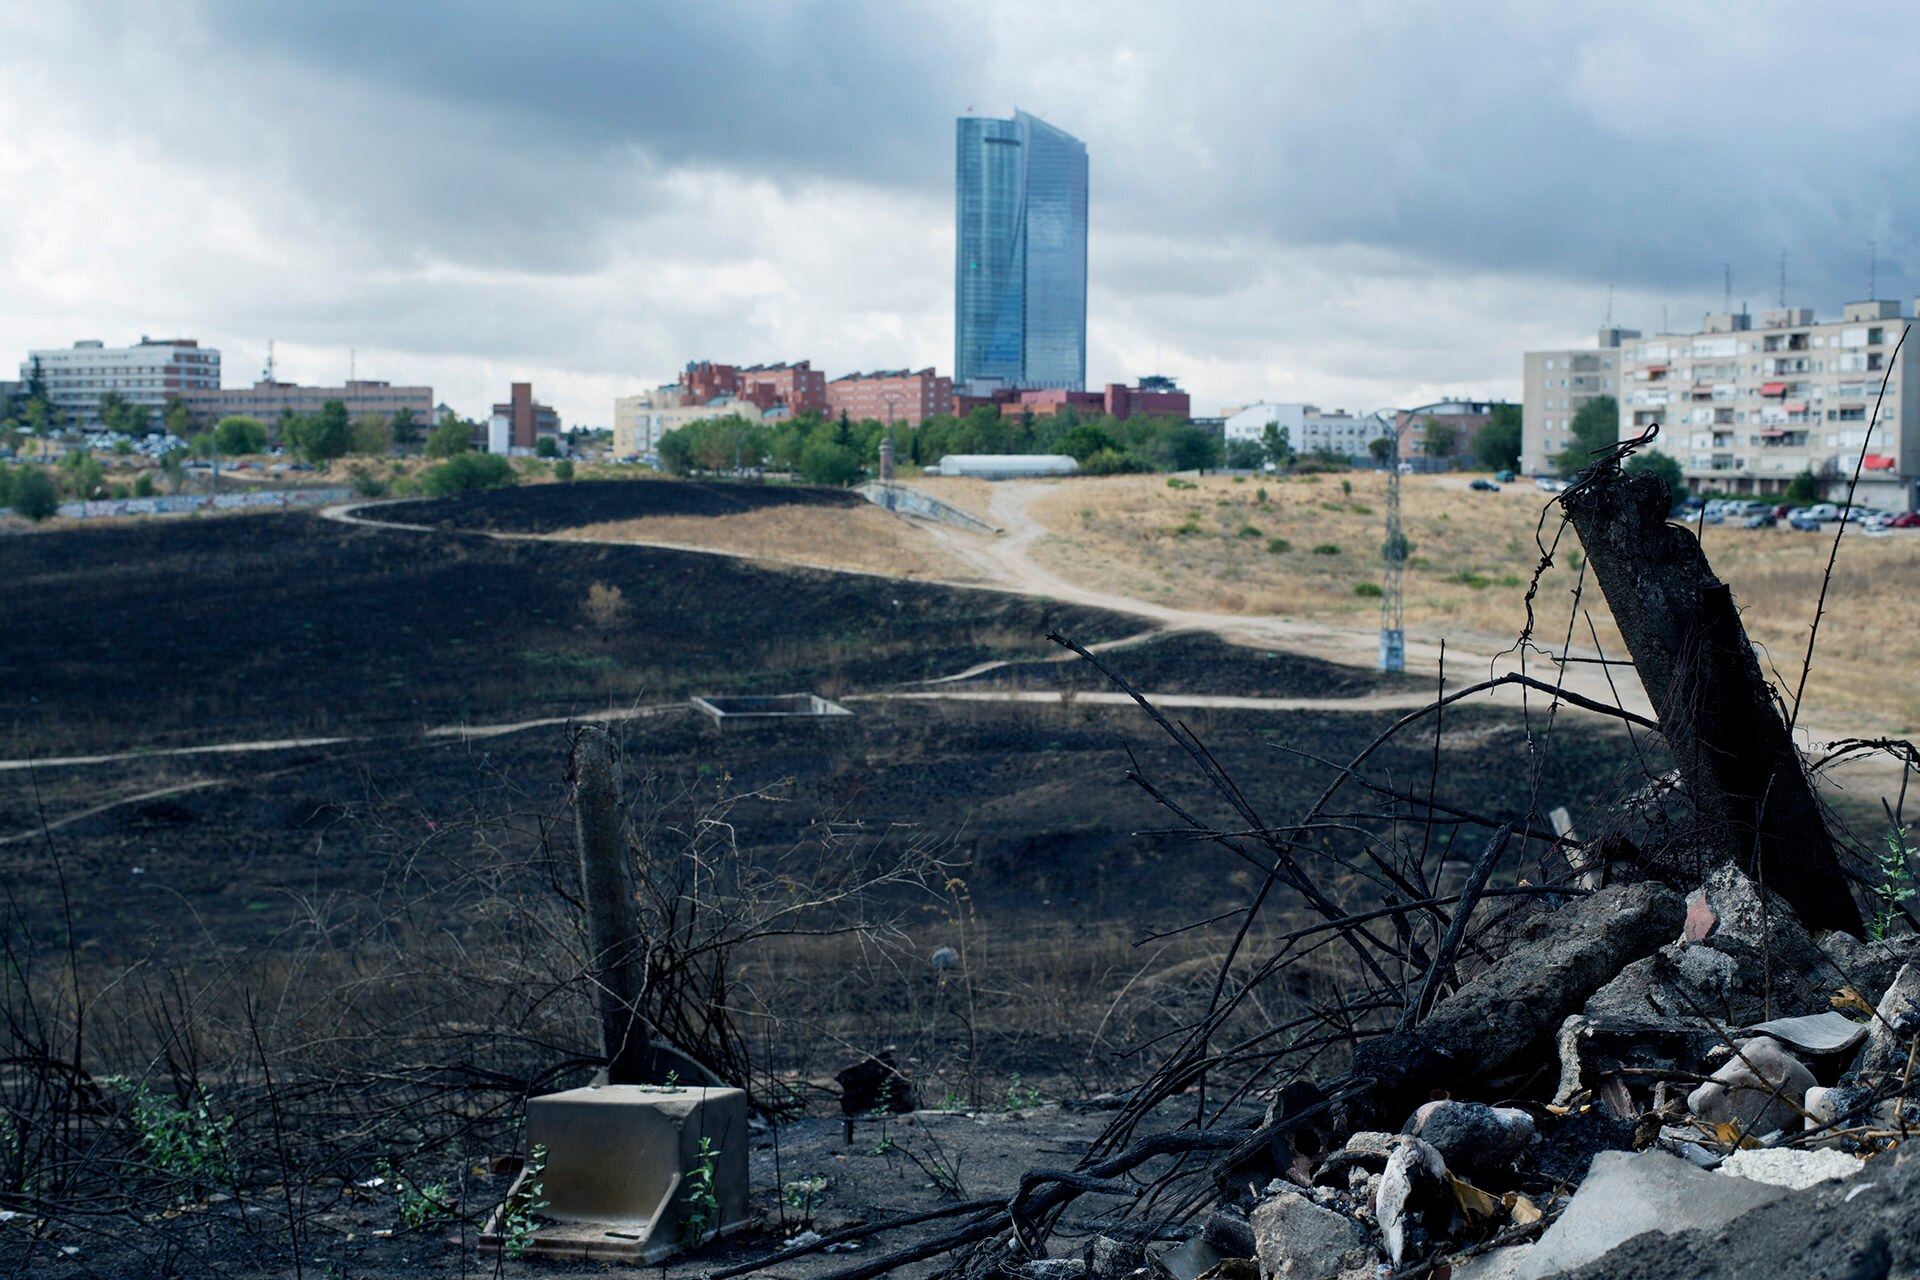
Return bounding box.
[1075,865,1920,1280]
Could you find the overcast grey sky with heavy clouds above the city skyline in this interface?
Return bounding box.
[0,0,1920,426]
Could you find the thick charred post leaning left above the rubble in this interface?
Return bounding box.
[1561,461,1860,935]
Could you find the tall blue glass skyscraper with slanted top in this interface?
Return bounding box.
[954,111,1087,391]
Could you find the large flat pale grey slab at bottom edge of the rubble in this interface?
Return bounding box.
[1497,1151,1788,1280]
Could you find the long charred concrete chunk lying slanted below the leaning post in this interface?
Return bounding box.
[1354,881,1686,1096]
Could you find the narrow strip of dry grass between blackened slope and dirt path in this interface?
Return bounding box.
[555,507,972,578]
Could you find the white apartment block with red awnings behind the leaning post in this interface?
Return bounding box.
[1620,301,1920,510]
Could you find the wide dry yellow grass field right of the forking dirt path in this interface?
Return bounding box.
[913,472,1920,733]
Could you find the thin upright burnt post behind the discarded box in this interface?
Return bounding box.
[572,725,653,1084]
